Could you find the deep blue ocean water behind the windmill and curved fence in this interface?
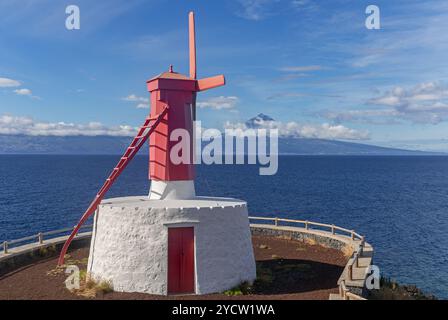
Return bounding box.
[0,155,448,298]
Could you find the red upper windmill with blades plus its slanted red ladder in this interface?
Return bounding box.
[58,12,225,265]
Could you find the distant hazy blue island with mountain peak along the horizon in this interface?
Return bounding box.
[0,113,446,156]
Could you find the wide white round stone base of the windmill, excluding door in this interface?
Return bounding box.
[87,197,256,295]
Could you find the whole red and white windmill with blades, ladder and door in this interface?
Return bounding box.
[58,12,255,294]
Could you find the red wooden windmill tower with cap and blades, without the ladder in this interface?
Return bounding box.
[147,12,225,181]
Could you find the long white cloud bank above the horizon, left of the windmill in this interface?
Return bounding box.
[0,115,137,137]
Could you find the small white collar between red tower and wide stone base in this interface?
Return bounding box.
[149,180,196,200]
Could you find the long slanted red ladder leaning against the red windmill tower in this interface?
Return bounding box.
[58,107,168,266]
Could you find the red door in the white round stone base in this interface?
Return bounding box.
[168,227,194,294]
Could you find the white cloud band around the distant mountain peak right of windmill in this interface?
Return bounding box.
[224,116,370,140]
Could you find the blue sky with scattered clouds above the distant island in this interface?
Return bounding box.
[0,0,448,151]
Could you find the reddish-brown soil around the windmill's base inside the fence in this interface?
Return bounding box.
[0,236,347,300]
